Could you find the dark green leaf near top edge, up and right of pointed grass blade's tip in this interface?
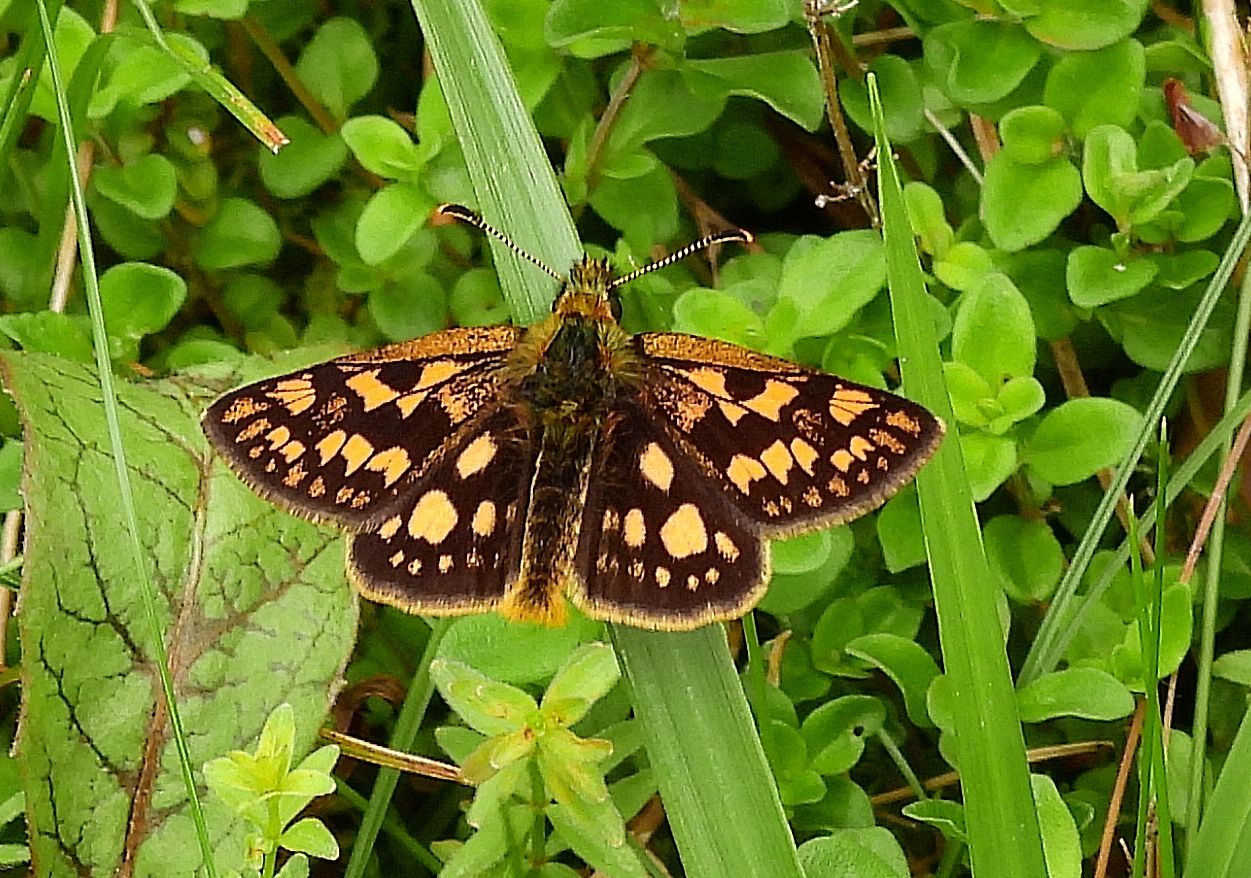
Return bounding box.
[923,20,1042,106]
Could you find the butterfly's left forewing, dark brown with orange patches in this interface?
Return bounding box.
[203,326,520,528]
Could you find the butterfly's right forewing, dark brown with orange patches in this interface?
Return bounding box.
[634,333,943,537]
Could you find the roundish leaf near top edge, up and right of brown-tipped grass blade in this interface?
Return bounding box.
[295,18,378,119]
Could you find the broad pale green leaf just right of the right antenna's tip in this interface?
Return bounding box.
[778,230,886,341]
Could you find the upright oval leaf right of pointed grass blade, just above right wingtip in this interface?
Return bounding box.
[951,271,1036,382]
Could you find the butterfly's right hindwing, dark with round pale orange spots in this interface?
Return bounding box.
[572,401,768,630]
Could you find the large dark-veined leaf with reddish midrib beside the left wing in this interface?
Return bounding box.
[0,354,357,878]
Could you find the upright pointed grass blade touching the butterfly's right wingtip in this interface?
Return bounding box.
[869,80,1047,875]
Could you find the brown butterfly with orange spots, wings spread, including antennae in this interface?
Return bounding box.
[203,205,945,630]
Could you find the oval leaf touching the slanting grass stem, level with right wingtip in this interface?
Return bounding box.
[1022,396,1142,485]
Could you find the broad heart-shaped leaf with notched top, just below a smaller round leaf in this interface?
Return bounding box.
[981,150,1082,251]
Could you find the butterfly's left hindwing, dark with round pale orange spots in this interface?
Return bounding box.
[348,406,534,615]
